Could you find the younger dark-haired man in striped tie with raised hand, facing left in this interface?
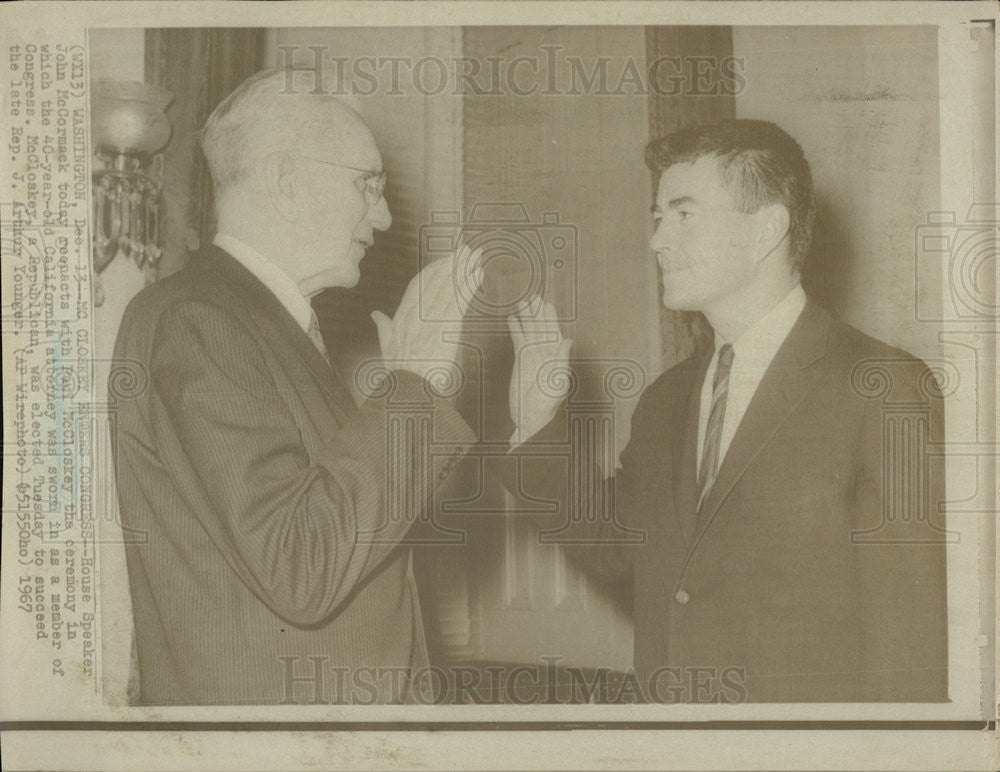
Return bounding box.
[511,120,948,702]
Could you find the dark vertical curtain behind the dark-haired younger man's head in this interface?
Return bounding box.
[646,27,736,360]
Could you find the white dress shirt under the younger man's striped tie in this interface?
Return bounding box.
[697,284,806,473]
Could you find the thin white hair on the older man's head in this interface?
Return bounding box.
[201,70,361,198]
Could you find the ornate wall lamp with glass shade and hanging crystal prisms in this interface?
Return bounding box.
[91,81,173,294]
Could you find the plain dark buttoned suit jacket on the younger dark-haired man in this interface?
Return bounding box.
[518,301,948,702]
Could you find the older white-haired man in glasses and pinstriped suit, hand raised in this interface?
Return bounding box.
[112,72,482,704]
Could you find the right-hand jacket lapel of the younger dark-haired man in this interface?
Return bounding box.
[697,300,830,539]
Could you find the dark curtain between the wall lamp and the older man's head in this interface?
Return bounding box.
[146,28,265,278]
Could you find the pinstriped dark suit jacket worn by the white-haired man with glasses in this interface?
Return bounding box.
[110,247,474,704]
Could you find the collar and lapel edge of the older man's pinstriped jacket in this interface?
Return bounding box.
[196,245,355,412]
